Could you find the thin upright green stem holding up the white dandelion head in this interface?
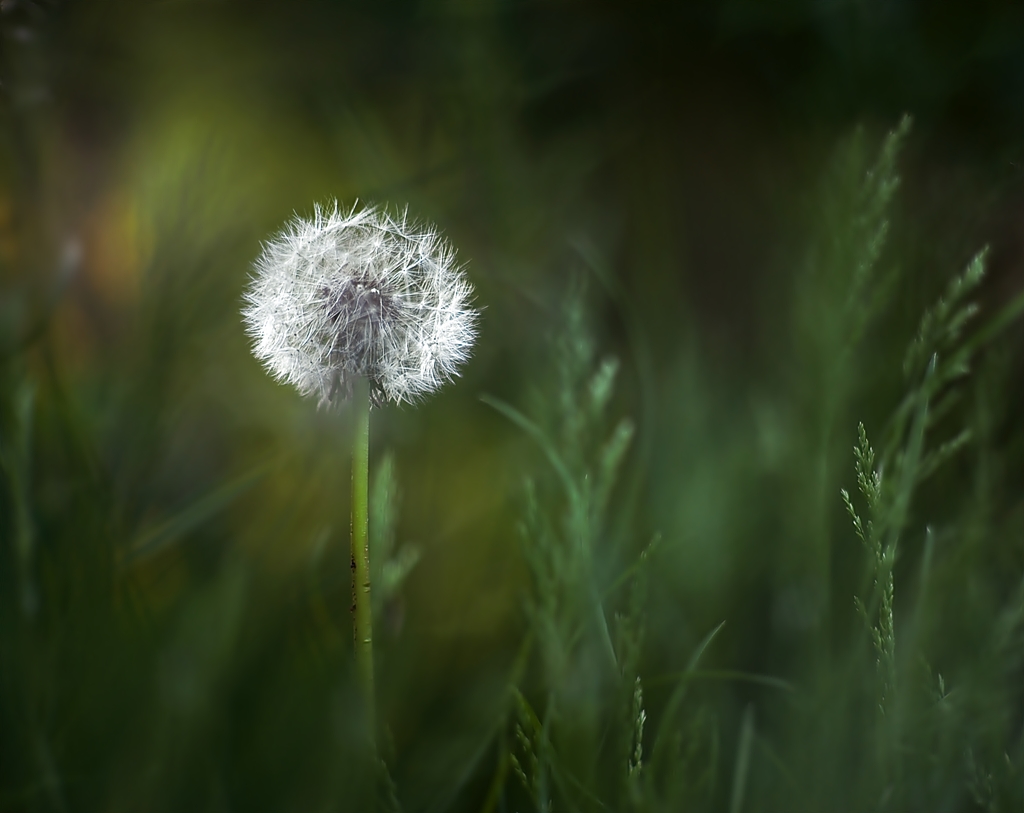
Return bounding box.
[351,380,376,741]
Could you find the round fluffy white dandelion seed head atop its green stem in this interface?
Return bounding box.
[243,203,477,404]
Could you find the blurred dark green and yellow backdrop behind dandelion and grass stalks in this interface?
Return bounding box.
[6,0,1024,810]
